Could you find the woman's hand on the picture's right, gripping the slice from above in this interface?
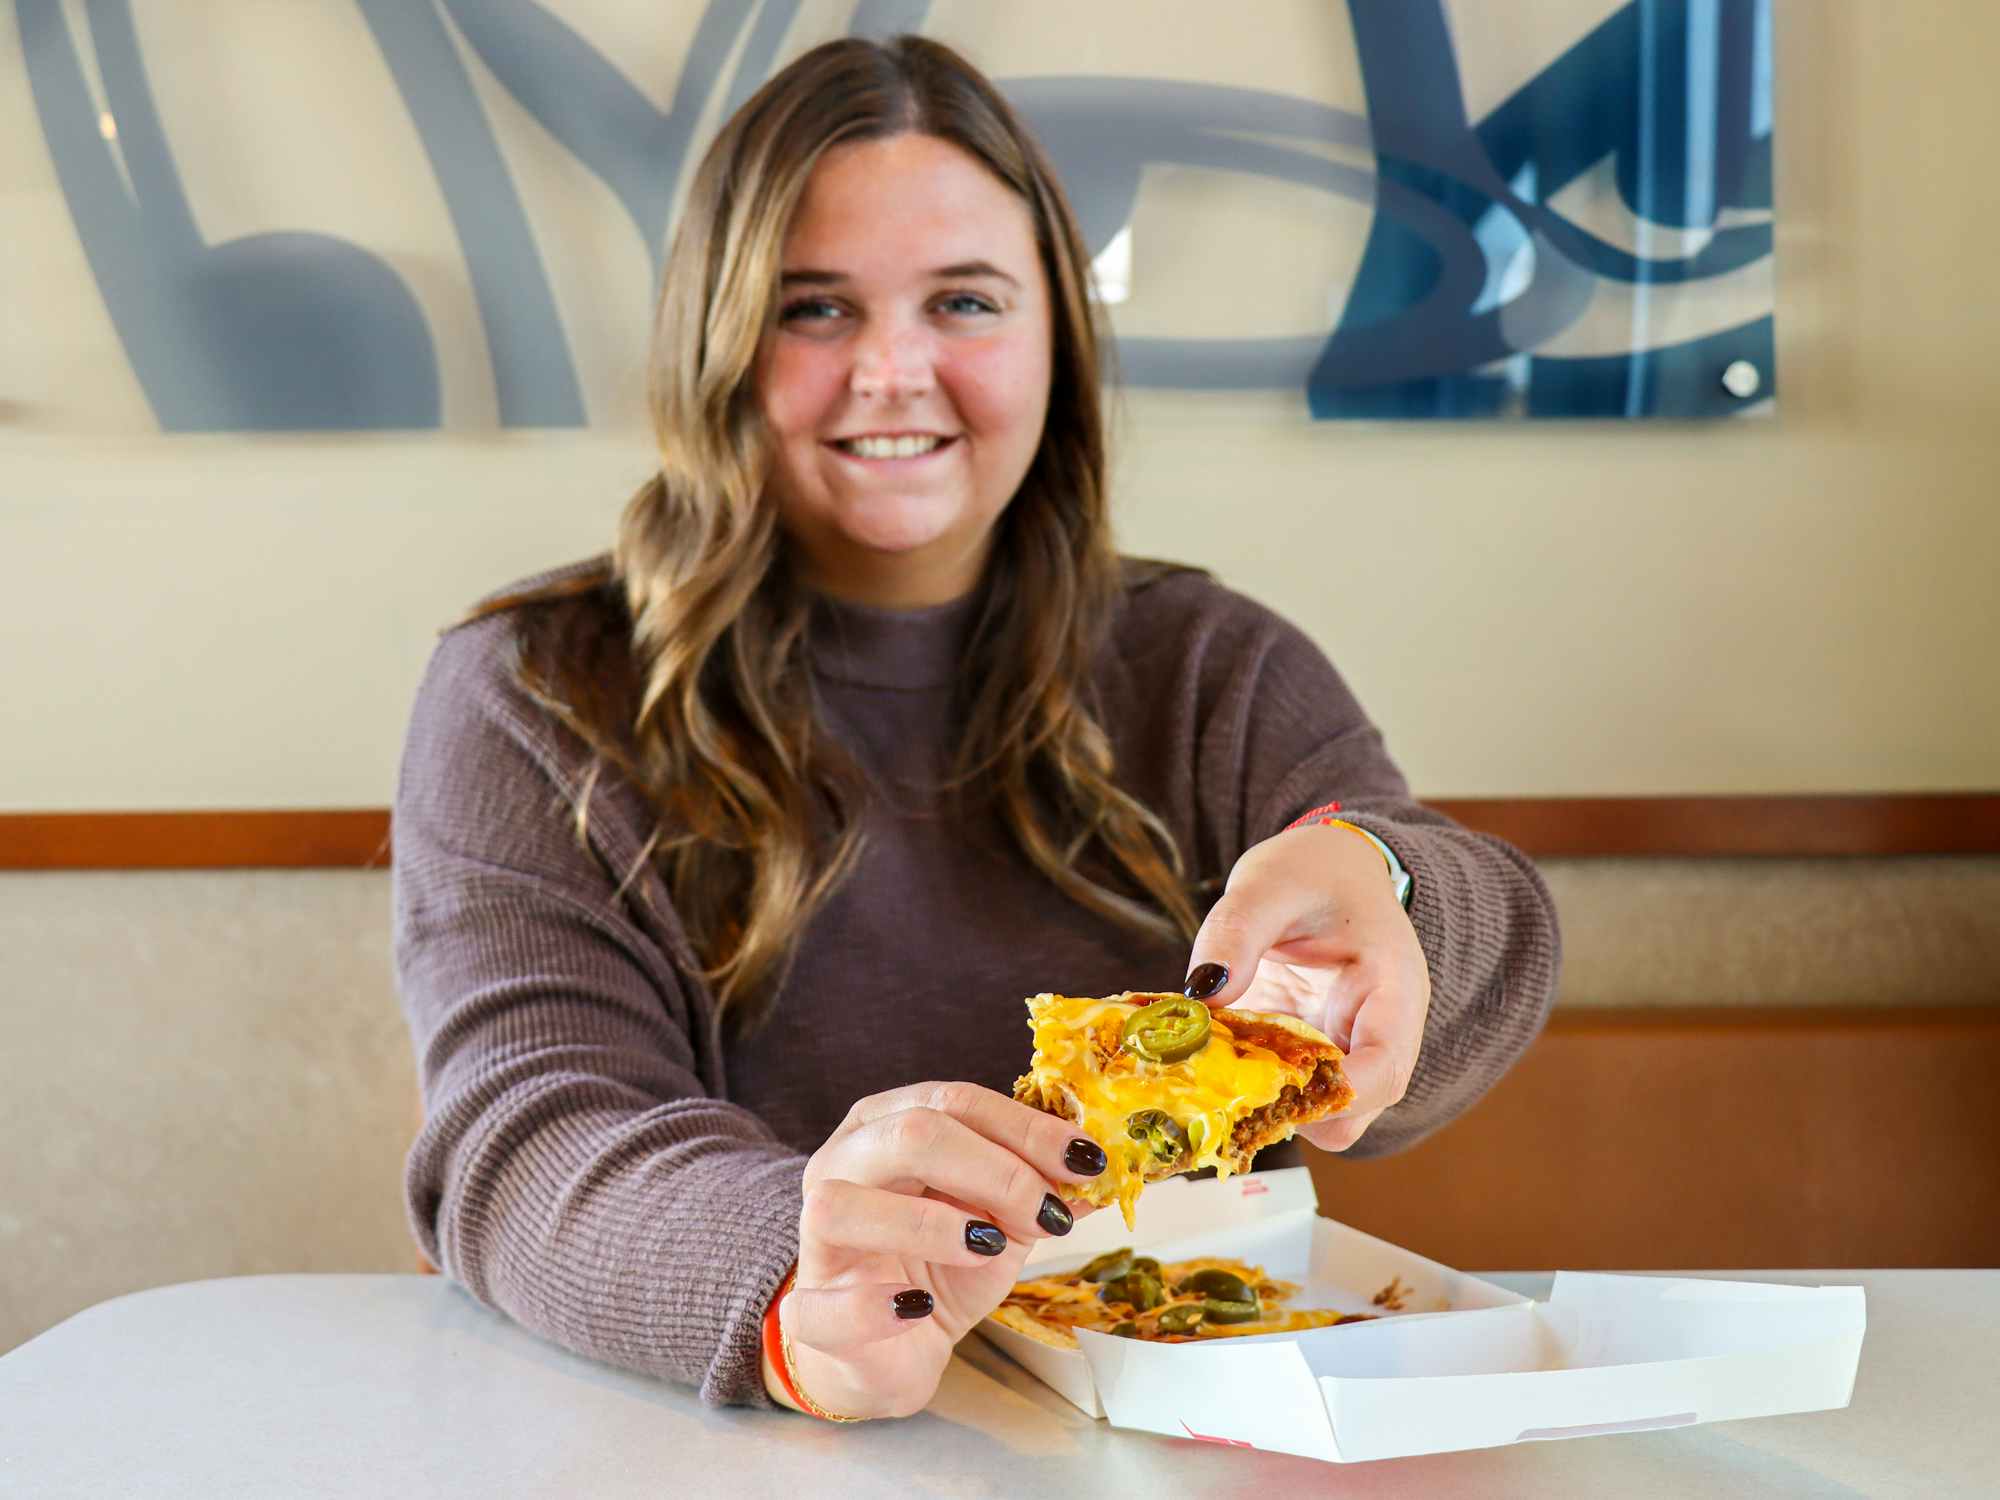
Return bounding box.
[1188,824,1430,1152]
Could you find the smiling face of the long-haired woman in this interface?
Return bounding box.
[756,134,1052,608]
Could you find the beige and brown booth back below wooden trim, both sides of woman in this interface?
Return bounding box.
[0,858,2000,1350]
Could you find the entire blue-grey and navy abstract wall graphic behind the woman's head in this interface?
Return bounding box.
[16,0,1776,432]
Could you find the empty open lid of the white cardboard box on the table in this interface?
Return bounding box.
[1078,1272,1866,1462]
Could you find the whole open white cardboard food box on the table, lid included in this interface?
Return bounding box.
[980,1168,1866,1462]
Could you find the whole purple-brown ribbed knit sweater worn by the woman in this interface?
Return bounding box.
[394,552,1558,1402]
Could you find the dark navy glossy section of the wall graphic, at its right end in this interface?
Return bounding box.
[1306,0,1772,416]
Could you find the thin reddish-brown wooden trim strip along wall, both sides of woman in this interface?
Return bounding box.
[0,792,2000,870]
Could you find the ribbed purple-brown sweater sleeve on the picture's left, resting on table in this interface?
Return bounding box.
[394,618,804,1402]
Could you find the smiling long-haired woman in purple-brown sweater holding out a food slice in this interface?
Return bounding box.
[396,38,1556,1418]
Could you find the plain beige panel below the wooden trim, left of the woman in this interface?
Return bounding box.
[0,870,416,1348]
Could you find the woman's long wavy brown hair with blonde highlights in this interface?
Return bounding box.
[482,36,1196,1028]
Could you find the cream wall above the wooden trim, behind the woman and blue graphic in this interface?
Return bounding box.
[0,0,2000,810]
